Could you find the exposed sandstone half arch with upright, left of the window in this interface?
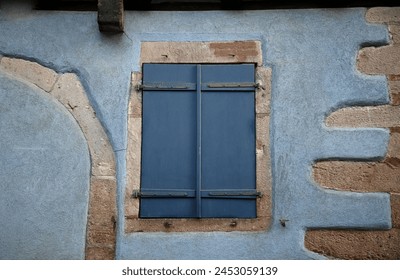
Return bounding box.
[0,56,116,259]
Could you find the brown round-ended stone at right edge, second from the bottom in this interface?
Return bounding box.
[313,162,400,192]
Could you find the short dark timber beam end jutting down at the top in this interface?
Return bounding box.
[97,0,124,33]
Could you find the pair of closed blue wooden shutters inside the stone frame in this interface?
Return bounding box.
[137,64,261,218]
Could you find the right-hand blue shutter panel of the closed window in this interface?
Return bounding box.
[202,65,256,218]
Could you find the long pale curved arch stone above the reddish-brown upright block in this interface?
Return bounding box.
[51,73,115,176]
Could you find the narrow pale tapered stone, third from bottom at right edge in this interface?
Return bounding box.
[325,105,400,128]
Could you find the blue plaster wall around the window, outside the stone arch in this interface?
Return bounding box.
[0,1,391,259]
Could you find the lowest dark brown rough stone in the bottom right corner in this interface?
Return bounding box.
[305,229,400,260]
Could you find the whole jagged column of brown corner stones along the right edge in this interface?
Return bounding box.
[305,8,400,259]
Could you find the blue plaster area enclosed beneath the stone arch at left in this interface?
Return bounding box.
[0,65,90,259]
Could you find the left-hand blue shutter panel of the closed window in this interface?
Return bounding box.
[140,64,197,218]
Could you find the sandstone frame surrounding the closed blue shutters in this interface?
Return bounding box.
[124,41,272,233]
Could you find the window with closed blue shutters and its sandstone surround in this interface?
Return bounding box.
[125,41,272,233]
